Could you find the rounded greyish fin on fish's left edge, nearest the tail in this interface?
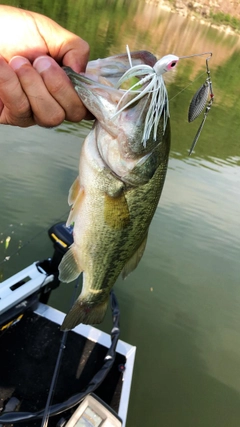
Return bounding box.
[58,243,83,283]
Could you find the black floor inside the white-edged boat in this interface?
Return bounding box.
[0,311,126,427]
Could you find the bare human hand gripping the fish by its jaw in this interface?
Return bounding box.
[0,6,89,127]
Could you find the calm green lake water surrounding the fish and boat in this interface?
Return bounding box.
[0,0,240,427]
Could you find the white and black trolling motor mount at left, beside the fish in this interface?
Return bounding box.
[0,222,73,330]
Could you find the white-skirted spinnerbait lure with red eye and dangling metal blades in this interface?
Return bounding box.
[112,46,214,155]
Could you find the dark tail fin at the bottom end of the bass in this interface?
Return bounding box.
[61,297,108,331]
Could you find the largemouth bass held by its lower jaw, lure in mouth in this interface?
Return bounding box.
[59,51,178,329]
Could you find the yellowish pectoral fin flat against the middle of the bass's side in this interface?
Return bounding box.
[104,192,130,229]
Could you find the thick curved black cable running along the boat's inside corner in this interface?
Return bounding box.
[0,291,120,424]
